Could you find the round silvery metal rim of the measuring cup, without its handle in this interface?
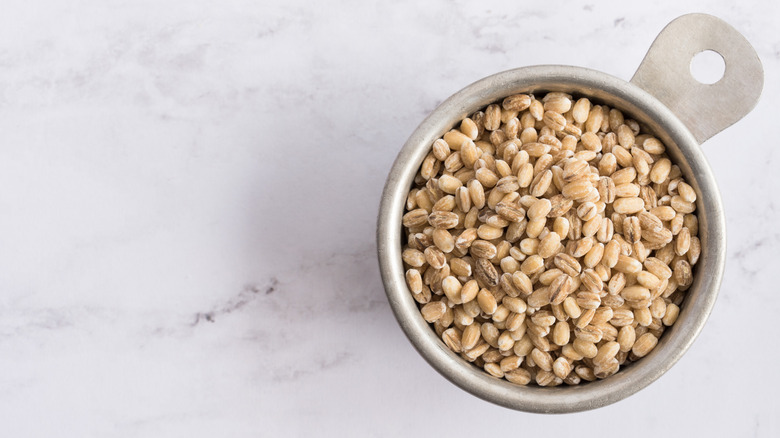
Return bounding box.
[377,65,726,413]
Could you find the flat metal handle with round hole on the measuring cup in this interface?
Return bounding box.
[631,14,764,144]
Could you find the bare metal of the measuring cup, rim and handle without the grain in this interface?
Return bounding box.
[377,14,763,413]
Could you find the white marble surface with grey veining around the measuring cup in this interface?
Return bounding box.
[0,0,780,437]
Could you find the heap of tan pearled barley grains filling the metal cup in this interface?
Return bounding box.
[403,92,701,386]
